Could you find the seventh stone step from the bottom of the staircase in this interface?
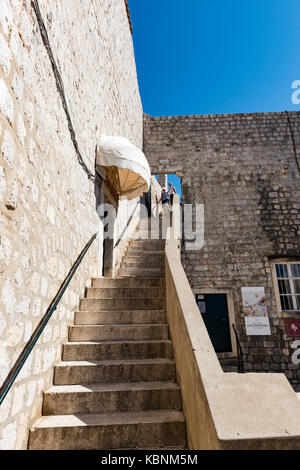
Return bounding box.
[80,297,165,312]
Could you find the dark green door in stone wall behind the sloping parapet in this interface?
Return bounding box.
[196,294,232,352]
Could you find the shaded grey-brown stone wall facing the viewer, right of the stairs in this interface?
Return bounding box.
[144,112,300,384]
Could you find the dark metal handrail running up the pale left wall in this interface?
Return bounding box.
[0,233,98,405]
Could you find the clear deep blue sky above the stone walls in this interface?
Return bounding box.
[129,0,300,116]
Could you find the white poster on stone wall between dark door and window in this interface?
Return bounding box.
[242,287,271,336]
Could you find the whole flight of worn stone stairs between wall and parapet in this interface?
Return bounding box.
[28,221,187,450]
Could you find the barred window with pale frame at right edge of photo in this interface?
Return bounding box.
[275,262,300,312]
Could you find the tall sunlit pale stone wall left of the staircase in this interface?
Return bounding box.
[0,0,143,449]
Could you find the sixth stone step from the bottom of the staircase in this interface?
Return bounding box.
[74,310,167,325]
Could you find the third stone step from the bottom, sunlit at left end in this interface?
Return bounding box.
[53,359,176,385]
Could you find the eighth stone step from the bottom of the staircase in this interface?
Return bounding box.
[85,287,166,299]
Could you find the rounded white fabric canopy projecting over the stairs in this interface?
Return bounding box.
[97,135,151,199]
